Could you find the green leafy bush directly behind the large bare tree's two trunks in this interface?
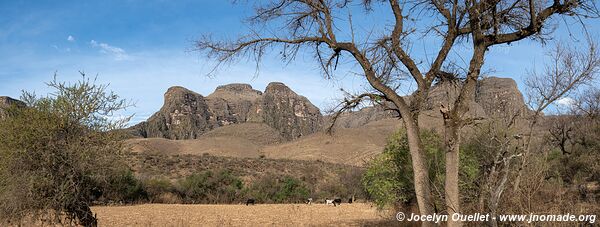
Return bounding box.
[362,130,478,208]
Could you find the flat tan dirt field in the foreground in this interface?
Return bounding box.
[92,203,396,226]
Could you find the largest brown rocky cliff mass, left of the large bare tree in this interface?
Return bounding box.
[133,83,323,140]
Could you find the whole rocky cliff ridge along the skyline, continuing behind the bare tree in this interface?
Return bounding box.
[133,77,529,140]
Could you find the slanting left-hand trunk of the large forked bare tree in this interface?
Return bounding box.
[403,115,435,226]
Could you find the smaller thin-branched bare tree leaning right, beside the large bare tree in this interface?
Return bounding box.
[472,41,600,226]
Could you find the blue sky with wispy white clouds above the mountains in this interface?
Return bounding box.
[0,0,600,122]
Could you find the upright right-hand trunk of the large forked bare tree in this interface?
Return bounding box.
[444,119,461,226]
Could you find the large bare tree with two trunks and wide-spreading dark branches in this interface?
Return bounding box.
[196,0,599,225]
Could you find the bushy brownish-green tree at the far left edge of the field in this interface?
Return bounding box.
[0,73,128,226]
